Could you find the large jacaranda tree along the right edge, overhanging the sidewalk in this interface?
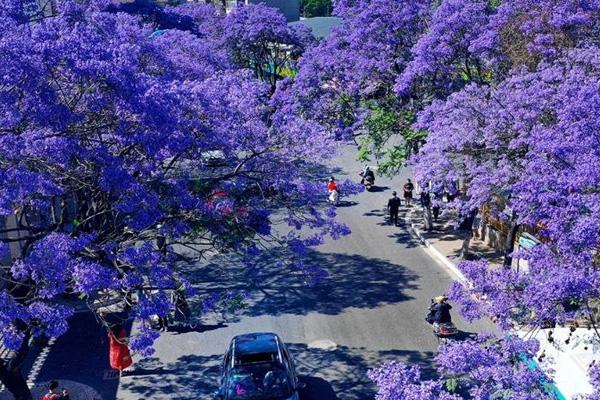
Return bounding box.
[372,0,600,399]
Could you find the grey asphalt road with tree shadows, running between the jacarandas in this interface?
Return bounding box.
[117,147,492,400]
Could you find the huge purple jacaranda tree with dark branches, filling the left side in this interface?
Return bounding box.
[0,0,347,400]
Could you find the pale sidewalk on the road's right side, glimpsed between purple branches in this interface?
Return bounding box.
[406,206,600,399]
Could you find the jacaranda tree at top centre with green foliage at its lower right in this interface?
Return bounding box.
[284,0,431,173]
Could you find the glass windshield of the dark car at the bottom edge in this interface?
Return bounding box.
[227,363,292,400]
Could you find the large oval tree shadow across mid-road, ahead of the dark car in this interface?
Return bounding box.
[191,251,419,316]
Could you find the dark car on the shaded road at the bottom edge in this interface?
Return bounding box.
[215,333,304,400]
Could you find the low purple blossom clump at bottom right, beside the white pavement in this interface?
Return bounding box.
[369,335,555,400]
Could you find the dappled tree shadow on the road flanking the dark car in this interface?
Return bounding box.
[119,343,435,400]
